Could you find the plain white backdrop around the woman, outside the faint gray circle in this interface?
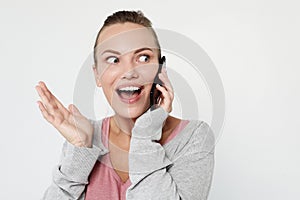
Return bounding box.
[0,0,300,200]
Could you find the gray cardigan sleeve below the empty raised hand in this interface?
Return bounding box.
[42,119,102,200]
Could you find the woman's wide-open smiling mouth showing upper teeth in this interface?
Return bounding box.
[116,86,144,103]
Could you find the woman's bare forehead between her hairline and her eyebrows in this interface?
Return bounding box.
[96,23,157,54]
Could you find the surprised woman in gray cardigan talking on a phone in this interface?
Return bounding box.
[36,11,214,200]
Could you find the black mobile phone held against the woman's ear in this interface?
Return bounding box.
[150,56,166,110]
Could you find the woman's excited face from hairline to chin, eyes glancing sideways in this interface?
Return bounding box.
[94,23,158,118]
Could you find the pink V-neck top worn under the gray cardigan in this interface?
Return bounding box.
[85,117,189,200]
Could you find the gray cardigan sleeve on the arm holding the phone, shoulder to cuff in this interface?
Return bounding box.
[126,109,214,200]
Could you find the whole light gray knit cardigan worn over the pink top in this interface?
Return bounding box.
[43,108,215,200]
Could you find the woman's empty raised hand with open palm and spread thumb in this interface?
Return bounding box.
[35,81,94,147]
